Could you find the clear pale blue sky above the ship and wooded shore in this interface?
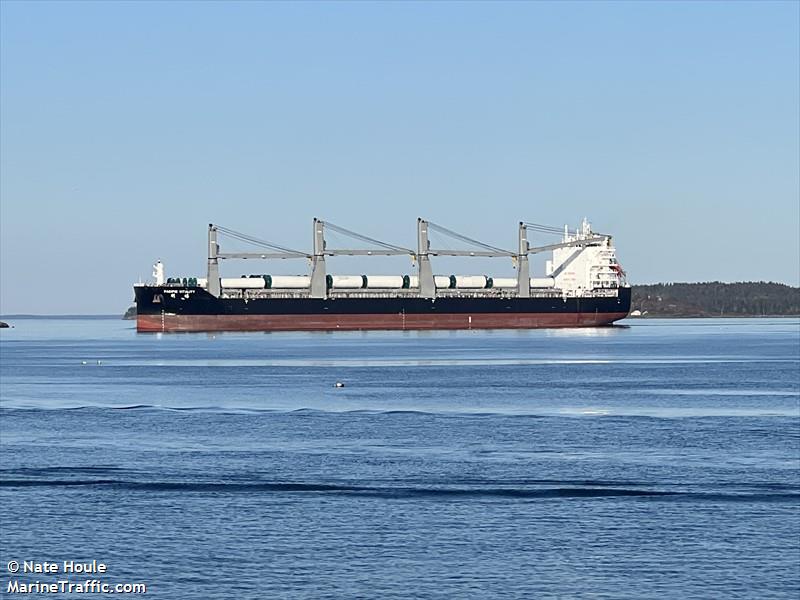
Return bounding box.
[0,0,800,314]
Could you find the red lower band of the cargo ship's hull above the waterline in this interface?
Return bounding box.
[136,312,628,332]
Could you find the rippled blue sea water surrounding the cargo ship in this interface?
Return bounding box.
[0,319,800,599]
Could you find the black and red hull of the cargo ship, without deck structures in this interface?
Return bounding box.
[135,286,630,332]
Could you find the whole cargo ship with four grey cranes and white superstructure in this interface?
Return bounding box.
[134,219,631,332]
